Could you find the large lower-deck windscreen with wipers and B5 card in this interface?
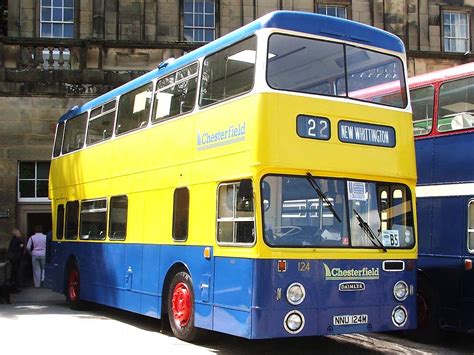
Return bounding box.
[261,175,415,250]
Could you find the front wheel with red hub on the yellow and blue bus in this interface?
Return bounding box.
[168,271,200,342]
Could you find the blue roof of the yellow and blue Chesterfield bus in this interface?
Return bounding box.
[59,11,405,122]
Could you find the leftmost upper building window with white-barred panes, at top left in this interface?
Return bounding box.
[40,0,74,38]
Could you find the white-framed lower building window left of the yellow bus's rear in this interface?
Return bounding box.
[18,161,50,202]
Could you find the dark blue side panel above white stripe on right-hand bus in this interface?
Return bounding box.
[433,131,474,183]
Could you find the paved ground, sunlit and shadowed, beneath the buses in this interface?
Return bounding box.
[0,287,474,355]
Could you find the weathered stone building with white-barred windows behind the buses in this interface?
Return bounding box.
[0,0,474,253]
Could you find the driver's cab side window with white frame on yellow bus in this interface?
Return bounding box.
[217,180,255,244]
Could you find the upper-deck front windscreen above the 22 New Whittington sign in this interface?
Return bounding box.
[267,34,407,108]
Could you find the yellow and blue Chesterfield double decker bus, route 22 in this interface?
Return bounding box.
[48,11,417,341]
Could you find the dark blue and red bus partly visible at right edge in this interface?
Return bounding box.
[409,63,474,332]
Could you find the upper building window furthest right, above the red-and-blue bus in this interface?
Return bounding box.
[443,11,469,53]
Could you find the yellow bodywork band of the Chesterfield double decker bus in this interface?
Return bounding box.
[50,93,417,259]
